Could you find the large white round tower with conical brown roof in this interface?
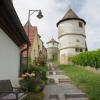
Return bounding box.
[57,9,87,64]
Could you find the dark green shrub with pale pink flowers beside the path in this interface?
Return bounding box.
[20,66,47,92]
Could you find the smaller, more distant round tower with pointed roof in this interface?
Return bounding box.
[47,38,59,61]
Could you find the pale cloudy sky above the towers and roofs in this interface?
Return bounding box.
[13,0,100,50]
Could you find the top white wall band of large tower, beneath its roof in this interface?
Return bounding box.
[58,20,85,36]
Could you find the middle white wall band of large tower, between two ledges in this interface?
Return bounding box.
[59,35,85,49]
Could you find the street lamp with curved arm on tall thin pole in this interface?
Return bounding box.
[27,10,43,67]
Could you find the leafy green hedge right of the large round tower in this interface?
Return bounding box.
[71,50,100,68]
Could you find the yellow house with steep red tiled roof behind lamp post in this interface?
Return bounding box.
[23,21,46,66]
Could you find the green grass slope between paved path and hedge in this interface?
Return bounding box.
[59,65,100,100]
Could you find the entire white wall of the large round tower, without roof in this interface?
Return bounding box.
[58,20,86,64]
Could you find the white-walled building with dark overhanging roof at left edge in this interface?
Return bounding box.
[0,0,29,85]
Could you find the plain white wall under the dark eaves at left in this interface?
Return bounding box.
[0,28,20,85]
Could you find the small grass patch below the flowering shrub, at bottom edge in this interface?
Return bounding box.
[27,92,45,100]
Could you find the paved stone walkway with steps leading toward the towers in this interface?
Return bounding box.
[44,63,88,100]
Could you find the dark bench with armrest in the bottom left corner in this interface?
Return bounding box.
[0,80,27,100]
